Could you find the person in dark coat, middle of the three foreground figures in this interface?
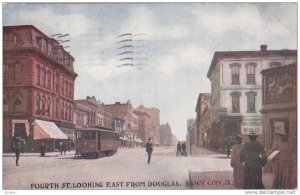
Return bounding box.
[240,133,267,189]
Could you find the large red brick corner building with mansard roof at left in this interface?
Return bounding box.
[3,25,77,152]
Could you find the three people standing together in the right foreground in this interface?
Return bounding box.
[231,133,297,189]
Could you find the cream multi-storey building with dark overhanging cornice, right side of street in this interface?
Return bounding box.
[207,45,297,149]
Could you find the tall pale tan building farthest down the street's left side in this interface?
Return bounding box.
[135,105,160,144]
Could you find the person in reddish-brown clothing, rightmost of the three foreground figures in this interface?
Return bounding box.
[272,132,297,189]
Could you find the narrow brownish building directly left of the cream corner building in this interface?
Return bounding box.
[195,93,212,147]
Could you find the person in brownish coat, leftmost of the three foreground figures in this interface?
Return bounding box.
[230,136,244,189]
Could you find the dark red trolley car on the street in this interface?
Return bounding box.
[75,127,119,158]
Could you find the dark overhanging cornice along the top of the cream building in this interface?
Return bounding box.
[206,49,297,78]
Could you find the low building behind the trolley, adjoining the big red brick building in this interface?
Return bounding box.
[74,96,114,130]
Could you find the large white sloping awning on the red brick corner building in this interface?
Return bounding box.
[33,119,68,139]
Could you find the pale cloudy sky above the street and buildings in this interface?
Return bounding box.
[2,2,298,140]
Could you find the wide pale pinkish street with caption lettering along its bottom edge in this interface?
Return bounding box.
[3,147,232,189]
